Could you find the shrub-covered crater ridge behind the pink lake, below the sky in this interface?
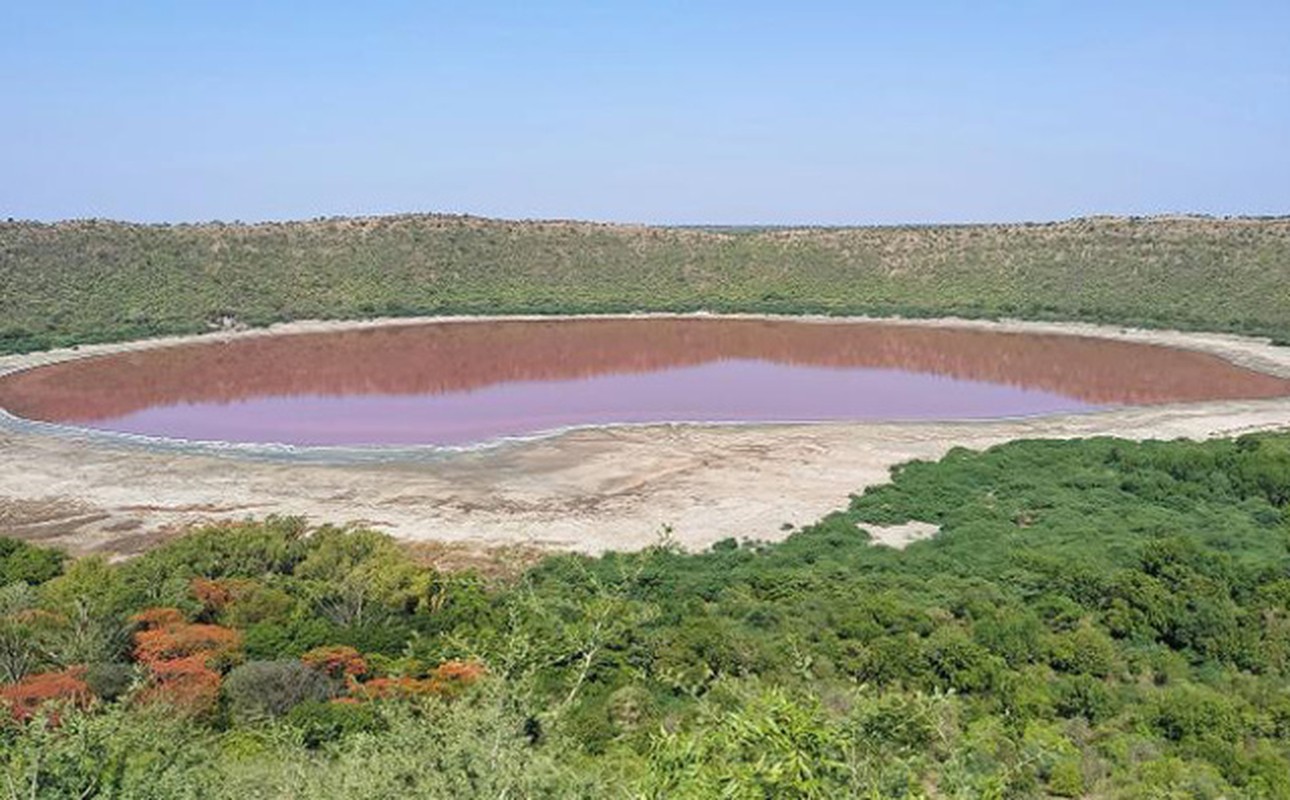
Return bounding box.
[0,215,1290,352]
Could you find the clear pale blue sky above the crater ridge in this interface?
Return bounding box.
[0,0,1290,223]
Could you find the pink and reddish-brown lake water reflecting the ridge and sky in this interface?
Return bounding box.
[0,319,1290,444]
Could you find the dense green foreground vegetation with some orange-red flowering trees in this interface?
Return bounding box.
[0,435,1290,797]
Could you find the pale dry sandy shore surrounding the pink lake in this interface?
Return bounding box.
[0,317,1290,555]
